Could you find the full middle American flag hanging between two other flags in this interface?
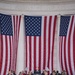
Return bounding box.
[24,16,57,72]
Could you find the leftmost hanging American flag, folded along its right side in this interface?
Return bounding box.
[0,14,21,75]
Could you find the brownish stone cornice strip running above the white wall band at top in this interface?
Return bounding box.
[0,0,75,5]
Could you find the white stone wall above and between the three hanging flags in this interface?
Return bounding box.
[0,1,75,74]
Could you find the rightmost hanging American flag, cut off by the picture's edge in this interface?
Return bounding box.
[59,16,75,75]
